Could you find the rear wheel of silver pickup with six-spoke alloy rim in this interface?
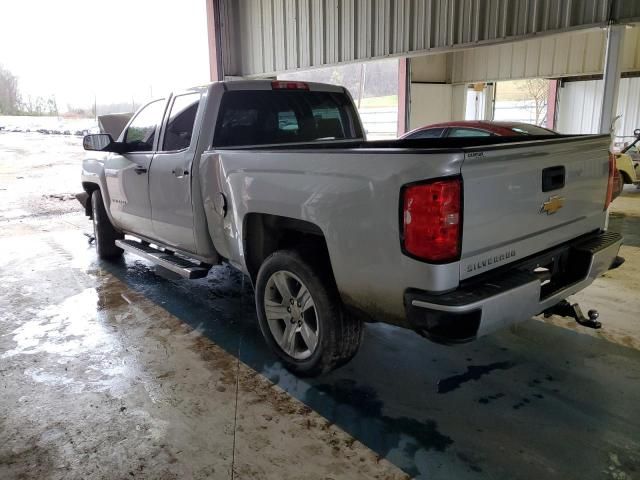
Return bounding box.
[256,250,363,376]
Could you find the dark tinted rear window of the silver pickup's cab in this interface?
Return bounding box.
[213,90,362,147]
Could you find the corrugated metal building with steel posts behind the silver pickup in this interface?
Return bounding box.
[206,0,640,139]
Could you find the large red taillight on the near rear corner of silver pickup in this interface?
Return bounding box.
[402,178,462,263]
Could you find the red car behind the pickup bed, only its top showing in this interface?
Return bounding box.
[400,120,558,138]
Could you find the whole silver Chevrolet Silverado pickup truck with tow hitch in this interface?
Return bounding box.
[79,80,621,375]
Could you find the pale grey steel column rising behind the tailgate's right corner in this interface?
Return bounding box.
[600,24,625,133]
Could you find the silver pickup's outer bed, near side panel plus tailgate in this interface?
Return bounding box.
[201,135,609,326]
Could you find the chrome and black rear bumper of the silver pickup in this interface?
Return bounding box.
[404,232,622,343]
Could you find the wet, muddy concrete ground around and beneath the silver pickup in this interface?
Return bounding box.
[0,134,640,480]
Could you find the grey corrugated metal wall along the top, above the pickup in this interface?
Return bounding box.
[219,0,640,76]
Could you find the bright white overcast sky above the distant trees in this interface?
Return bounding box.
[0,0,209,110]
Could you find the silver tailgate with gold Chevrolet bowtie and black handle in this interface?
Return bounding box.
[460,135,610,280]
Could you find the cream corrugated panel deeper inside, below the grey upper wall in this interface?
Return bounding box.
[451,25,640,83]
